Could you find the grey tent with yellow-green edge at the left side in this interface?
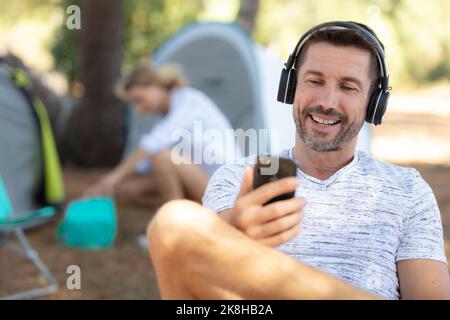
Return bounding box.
[0,57,64,219]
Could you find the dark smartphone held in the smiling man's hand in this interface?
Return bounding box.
[253,155,298,205]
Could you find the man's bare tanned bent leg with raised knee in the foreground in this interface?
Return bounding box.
[147,200,374,299]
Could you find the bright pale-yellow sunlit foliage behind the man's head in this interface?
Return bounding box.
[254,0,450,88]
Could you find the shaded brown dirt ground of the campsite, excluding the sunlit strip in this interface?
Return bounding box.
[0,145,450,299]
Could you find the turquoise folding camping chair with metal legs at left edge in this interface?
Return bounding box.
[0,177,58,300]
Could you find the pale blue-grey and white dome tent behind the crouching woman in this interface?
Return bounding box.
[128,23,370,159]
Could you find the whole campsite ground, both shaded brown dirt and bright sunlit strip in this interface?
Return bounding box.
[0,112,450,299]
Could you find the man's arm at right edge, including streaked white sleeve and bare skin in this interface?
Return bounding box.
[397,171,450,299]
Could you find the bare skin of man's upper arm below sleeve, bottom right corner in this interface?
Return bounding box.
[397,259,450,300]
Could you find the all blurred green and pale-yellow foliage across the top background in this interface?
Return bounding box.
[0,0,450,88]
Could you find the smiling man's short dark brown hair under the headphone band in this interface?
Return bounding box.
[295,22,380,91]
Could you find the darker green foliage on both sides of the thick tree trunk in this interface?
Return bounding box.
[52,0,202,89]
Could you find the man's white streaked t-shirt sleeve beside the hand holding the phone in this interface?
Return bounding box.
[203,164,245,213]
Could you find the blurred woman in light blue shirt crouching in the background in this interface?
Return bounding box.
[85,64,238,204]
